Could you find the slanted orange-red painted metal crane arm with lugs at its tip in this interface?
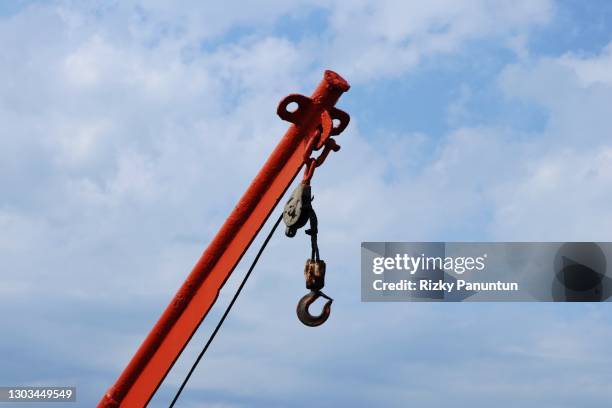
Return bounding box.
[98,71,349,408]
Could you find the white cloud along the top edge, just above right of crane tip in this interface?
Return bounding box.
[323,0,554,82]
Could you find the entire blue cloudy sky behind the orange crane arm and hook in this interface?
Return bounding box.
[0,0,612,408]
